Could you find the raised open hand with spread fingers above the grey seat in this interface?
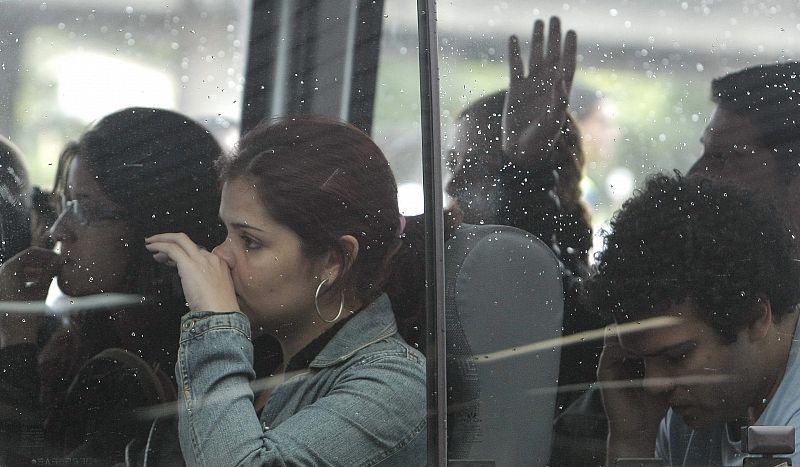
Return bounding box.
[502,16,577,168]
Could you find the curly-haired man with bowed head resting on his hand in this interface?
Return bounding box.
[589,175,800,466]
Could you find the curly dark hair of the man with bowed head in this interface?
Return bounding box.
[588,174,800,343]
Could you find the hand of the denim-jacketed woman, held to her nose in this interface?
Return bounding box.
[145,233,239,312]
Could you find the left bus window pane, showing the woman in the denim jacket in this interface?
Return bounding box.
[0,0,440,465]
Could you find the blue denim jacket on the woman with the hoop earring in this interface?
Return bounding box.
[175,295,427,467]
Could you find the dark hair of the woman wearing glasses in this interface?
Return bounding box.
[78,107,225,305]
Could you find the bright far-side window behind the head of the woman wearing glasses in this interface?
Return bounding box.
[0,0,250,186]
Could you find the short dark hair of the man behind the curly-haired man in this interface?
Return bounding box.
[711,62,800,176]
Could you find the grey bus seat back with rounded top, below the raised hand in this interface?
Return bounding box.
[445,224,564,466]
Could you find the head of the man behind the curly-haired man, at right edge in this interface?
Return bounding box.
[689,62,800,238]
